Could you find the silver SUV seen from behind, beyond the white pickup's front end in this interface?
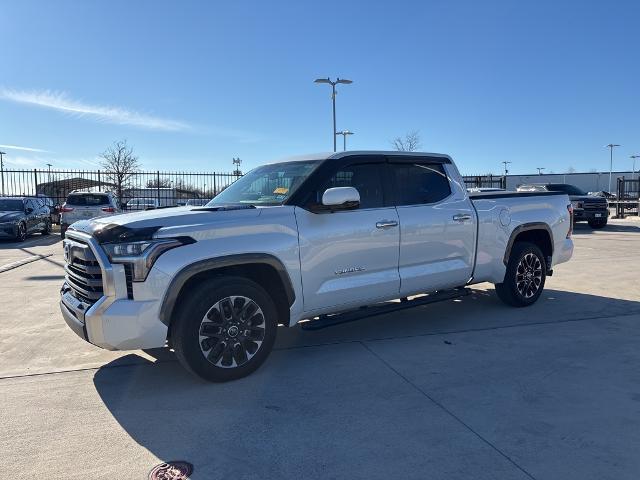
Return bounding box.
[60,192,121,238]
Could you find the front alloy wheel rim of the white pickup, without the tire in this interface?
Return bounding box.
[198,296,266,368]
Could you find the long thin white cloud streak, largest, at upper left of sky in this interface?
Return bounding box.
[0,88,191,131]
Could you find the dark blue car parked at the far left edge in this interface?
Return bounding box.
[0,197,51,242]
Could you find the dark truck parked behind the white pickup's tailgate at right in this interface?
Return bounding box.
[517,183,609,228]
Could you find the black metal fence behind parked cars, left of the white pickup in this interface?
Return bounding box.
[0,169,239,207]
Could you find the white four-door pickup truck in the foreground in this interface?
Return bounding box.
[60,151,573,381]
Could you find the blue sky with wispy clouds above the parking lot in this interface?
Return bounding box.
[0,0,640,174]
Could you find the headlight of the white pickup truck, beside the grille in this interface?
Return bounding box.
[102,238,193,282]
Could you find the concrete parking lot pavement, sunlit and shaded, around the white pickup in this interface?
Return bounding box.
[0,220,640,480]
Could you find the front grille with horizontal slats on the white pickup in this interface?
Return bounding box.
[64,240,104,304]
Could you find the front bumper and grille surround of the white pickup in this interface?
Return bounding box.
[60,231,168,350]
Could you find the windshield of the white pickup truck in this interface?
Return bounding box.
[207,160,320,206]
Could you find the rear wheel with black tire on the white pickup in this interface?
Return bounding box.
[495,242,547,307]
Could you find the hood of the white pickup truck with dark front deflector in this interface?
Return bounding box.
[69,205,261,243]
